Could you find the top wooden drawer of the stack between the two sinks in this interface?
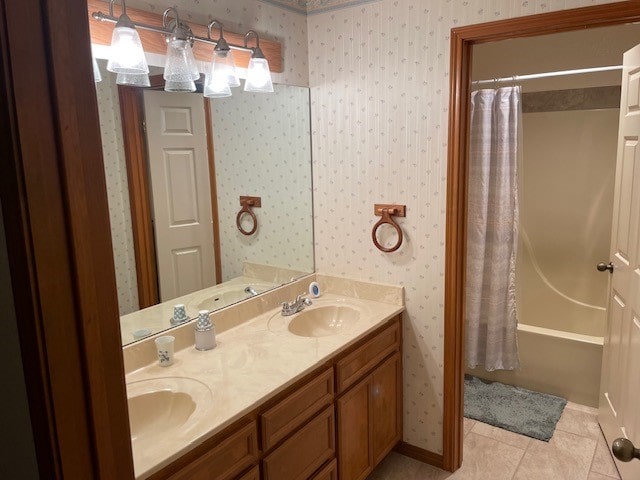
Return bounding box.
[261,368,333,451]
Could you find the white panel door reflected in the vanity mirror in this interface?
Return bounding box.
[144,91,216,301]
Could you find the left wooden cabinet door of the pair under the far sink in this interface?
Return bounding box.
[336,375,373,480]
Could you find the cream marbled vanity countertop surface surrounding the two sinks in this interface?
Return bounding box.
[126,289,404,478]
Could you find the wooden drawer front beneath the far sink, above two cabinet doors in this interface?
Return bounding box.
[336,319,400,393]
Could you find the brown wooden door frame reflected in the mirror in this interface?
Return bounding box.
[118,75,222,308]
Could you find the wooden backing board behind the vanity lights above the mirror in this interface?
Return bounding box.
[87,0,283,73]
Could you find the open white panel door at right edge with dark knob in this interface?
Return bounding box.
[598,45,640,480]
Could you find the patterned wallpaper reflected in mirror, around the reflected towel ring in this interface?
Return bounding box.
[211,85,313,281]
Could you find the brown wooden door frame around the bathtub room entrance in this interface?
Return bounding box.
[443,0,640,471]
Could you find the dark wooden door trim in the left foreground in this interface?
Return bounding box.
[0,0,133,478]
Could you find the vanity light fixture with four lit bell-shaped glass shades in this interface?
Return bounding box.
[92,0,273,98]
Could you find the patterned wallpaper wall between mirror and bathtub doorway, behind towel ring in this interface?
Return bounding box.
[308,0,607,453]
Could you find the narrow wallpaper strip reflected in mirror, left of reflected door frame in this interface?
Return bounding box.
[96,61,139,315]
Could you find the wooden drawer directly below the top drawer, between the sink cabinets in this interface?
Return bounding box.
[262,405,335,480]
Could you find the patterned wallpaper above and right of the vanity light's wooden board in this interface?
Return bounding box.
[127,0,309,87]
